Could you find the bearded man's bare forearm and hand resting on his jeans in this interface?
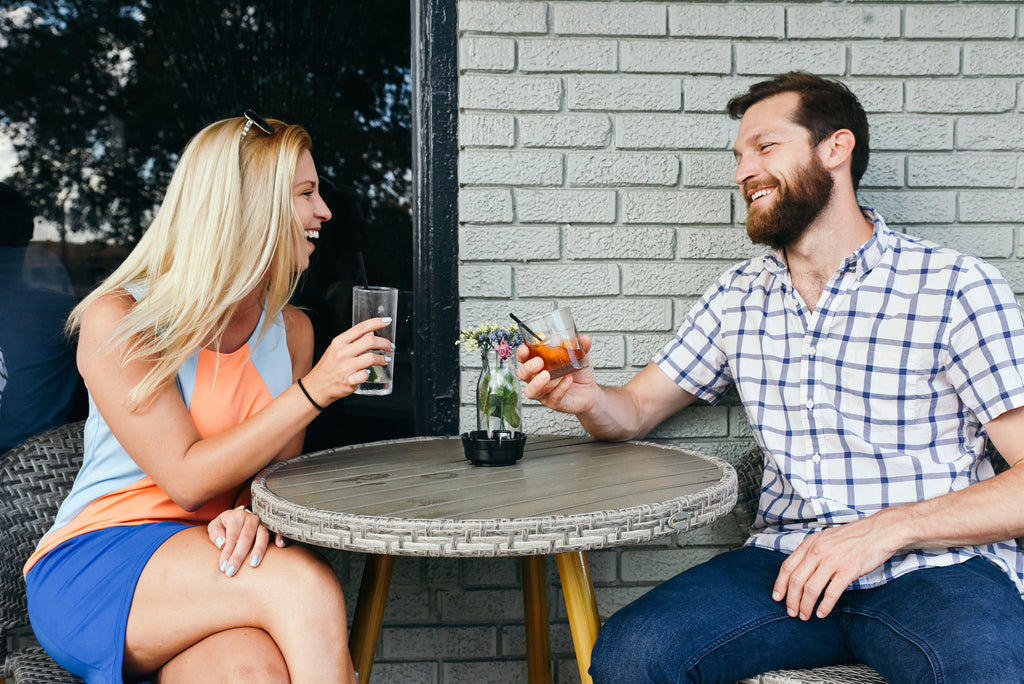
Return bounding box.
[772,408,1024,619]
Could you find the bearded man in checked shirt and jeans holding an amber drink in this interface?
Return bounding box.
[517,73,1024,683]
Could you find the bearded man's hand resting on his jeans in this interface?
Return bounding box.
[772,509,900,619]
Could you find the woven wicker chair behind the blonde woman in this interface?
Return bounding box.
[0,423,84,684]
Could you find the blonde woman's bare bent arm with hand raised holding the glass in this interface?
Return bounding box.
[78,293,390,510]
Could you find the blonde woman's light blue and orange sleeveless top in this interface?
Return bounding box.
[25,288,292,572]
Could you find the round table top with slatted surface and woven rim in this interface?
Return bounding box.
[252,435,736,557]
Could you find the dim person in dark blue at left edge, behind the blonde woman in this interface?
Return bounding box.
[0,183,81,453]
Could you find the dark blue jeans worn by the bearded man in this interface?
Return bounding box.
[590,547,1024,684]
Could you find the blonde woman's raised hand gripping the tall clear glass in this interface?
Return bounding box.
[302,318,394,405]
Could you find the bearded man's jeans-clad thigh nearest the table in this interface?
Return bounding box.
[591,547,851,683]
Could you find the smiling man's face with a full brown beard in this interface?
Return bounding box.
[733,92,835,249]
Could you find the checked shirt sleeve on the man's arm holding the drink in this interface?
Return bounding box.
[653,275,733,403]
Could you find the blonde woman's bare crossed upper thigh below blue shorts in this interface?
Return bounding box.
[125,527,345,675]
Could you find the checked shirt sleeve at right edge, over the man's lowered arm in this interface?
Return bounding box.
[946,257,1024,423]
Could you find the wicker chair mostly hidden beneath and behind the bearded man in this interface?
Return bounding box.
[736,447,886,684]
